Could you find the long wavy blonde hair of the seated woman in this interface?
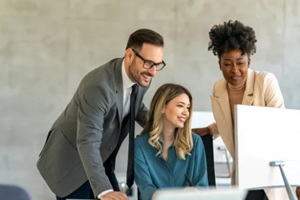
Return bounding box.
[141,83,194,160]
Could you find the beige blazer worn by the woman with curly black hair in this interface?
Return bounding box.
[209,69,290,200]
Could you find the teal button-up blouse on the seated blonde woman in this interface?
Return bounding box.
[134,133,208,200]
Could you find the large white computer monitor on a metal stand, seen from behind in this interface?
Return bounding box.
[235,105,300,189]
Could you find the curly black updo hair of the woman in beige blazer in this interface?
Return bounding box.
[208,20,257,58]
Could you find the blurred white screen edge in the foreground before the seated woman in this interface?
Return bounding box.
[152,188,246,200]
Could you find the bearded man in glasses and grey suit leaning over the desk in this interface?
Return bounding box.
[37,29,165,200]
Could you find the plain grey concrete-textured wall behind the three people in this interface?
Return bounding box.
[0,0,300,199]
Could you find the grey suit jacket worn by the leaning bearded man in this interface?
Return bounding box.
[37,58,148,197]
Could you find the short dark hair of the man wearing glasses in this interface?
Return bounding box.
[126,29,164,51]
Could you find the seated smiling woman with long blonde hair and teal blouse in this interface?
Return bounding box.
[134,83,208,200]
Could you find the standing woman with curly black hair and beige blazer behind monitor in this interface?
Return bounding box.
[193,21,300,200]
